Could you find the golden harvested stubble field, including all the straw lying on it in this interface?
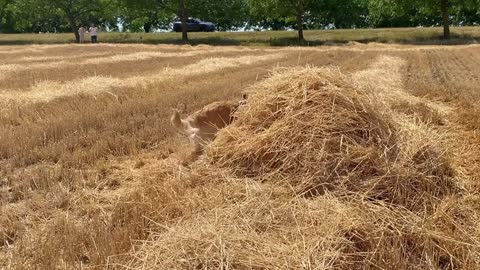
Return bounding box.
[0,44,480,269]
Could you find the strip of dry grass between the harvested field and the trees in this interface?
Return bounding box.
[0,26,480,46]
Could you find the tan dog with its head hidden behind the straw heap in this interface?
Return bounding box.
[170,98,246,164]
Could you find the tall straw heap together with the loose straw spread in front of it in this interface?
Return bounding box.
[126,68,480,269]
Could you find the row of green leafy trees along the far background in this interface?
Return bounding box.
[0,0,480,41]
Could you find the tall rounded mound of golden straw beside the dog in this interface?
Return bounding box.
[208,68,456,211]
